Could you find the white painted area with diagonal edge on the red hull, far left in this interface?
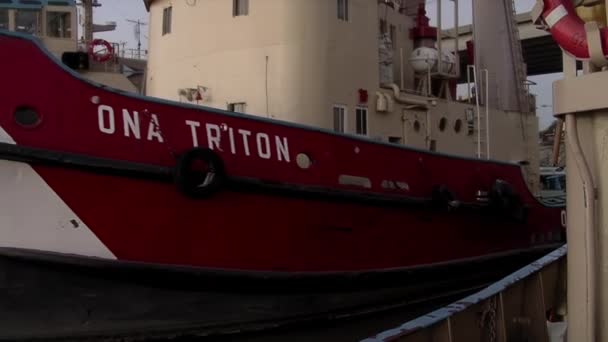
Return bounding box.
[0,127,116,259]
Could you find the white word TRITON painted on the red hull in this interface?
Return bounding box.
[186,120,291,163]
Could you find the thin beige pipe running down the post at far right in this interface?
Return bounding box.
[566,114,597,341]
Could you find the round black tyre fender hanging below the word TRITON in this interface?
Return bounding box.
[174,148,226,198]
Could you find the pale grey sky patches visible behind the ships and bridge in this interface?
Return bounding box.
[94,0,561,128]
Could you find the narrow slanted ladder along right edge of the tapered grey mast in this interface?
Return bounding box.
[503,0,530,113]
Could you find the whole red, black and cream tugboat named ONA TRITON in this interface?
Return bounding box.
[0,0,564,338]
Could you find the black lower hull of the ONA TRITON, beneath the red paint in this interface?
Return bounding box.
[0,246,553,341]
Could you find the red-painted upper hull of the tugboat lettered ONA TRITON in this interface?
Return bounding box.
[0,33,563,272]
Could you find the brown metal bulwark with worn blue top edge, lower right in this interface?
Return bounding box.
[364,245,567,342]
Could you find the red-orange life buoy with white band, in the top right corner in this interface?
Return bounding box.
[541,0,608,59]
